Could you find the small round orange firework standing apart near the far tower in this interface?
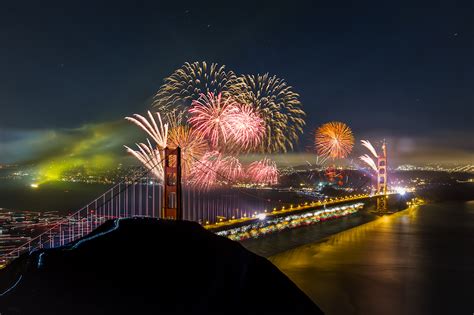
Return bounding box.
[314,121,354,159]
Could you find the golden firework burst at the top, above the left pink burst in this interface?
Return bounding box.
[153,61,239,111]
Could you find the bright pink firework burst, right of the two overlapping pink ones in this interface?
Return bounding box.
[230,104,265,151]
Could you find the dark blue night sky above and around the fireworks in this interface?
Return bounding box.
[0,1,474,162]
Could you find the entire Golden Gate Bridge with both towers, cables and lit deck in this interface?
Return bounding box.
[0,144,395,265]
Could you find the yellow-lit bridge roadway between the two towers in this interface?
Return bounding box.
[203,192,388,231]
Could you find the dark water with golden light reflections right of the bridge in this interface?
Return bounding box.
[270,202,474,314]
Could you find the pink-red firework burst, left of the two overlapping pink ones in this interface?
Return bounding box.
[188,93,239,149]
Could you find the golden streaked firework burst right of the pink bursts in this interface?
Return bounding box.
[233,73,306,152]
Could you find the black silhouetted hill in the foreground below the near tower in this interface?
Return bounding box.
[0,218,322,315]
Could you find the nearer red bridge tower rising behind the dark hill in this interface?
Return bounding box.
[161,147,183,220]
